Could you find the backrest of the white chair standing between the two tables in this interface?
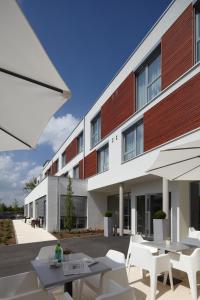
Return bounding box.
[130,243,153,270]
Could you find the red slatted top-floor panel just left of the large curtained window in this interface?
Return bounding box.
[101,73,135,138]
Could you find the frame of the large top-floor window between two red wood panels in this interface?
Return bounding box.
[135,45,162,112]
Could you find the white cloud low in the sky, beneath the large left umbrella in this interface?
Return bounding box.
[0,154,42,205]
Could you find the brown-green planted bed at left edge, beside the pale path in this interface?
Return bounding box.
[0,219,16,245]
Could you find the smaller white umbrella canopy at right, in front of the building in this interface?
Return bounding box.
[147,141,200,181]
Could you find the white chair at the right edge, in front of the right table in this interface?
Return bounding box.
[170,248,200,300]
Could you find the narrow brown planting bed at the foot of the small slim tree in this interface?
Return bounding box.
[53,229,103,239]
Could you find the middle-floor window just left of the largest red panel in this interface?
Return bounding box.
[123,122,144,161]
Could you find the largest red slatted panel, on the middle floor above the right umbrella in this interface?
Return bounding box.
[144,74,200,151]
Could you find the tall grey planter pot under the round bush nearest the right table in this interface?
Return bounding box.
[153,219,169,241]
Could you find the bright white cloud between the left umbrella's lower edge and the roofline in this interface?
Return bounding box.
[39,114,79,152]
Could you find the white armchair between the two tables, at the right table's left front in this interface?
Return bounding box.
[130,243,173,300]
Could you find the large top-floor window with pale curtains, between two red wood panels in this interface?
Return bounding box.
[136,48,161,110]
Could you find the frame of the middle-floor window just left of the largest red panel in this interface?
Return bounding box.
[122,119,144,163]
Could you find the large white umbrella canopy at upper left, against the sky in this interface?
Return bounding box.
[0,0,71,151]
